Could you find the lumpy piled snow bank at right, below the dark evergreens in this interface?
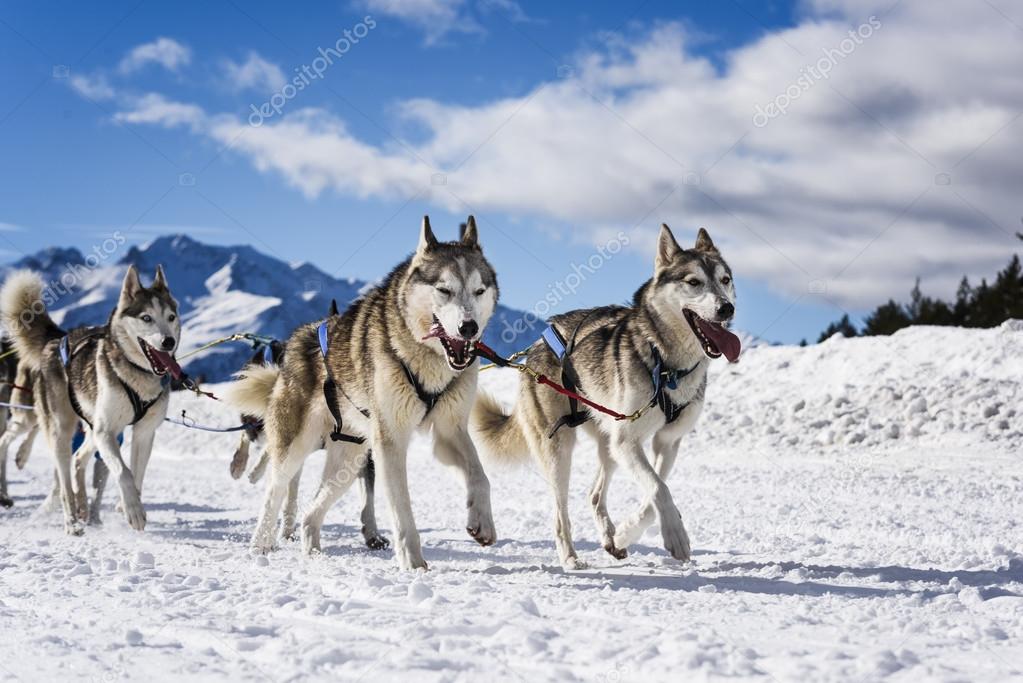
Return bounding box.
[694,320,1023,451]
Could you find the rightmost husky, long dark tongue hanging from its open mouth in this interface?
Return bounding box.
[473,225,740,570]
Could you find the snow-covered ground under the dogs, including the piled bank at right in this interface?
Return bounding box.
[0,323,1023,683]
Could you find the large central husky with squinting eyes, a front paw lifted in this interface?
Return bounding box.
[231,217,498,570]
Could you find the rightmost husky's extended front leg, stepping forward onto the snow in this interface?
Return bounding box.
[611,435,692,562]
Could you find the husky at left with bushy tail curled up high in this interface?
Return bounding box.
[0,266,181,535]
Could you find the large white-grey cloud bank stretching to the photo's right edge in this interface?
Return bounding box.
[87,0,1023,306]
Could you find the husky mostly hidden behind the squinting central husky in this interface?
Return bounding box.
[230,339,391,550]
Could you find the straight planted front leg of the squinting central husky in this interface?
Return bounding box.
[372,427,429,570]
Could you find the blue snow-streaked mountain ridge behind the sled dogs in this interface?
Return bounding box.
[0,233,535,381]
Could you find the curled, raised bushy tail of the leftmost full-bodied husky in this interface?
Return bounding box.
[0,270,63,369]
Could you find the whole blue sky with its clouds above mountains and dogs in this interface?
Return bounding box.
[0,0,1023,342]
